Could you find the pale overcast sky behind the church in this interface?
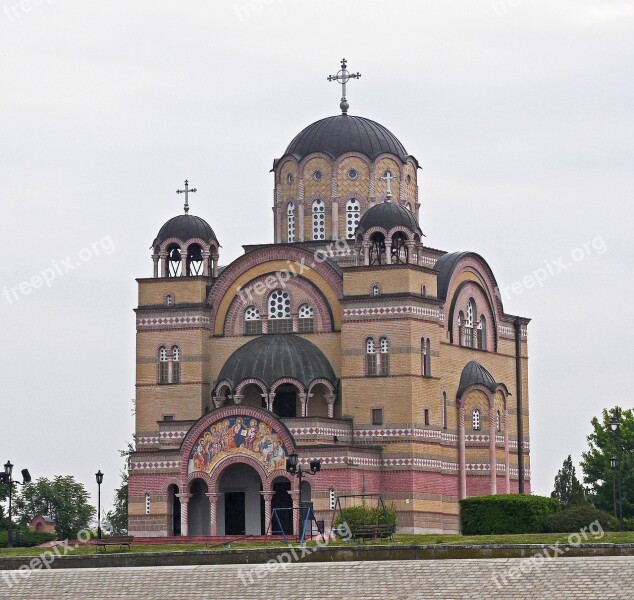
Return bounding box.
[0,0,634,516]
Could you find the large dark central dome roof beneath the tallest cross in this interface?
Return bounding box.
[284,115,408,162]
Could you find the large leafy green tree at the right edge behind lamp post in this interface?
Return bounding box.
[581,408,634,517]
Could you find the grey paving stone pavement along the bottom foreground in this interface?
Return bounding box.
[0,557,634,600]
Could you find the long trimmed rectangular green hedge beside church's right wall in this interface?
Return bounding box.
[460,494,559,535]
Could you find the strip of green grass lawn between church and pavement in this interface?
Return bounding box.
[0,531,634,557]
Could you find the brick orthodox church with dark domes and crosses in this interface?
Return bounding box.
[129,61,530,537]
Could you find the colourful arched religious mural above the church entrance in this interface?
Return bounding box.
[189,416,287,473]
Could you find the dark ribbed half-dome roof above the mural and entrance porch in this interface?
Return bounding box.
[218,334,336,388]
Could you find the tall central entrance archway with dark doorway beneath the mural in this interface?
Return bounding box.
[216,463,264,535]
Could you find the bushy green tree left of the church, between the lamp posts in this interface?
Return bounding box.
[15,475,96,539]
